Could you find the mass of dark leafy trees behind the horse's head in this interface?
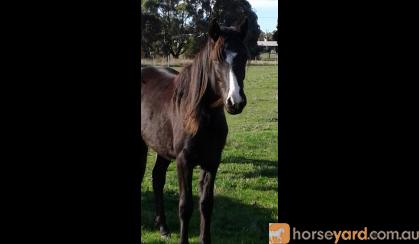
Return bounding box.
[141,0,261,58]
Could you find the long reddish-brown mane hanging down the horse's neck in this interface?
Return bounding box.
[173,36,224,135]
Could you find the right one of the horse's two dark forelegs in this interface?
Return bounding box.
[199,169,217,244]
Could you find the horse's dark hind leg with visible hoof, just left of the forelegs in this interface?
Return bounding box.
[153,155,170,237]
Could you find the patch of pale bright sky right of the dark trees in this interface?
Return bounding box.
[247,0,278,32]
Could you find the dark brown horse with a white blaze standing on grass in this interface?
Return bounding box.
[140,19,248,244]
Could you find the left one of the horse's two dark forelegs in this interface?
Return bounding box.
[176,153,193,244]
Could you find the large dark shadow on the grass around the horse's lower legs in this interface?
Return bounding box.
[141,191,277,243]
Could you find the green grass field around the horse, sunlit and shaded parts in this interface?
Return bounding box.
[141,66,278,244]
